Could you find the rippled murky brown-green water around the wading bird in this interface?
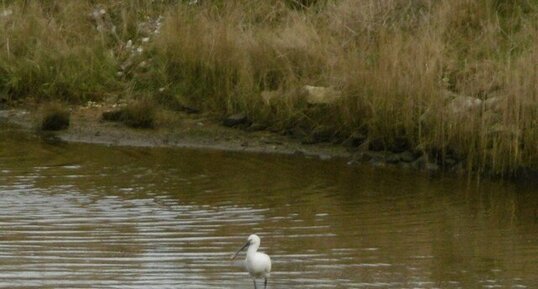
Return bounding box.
[0,125,538,289]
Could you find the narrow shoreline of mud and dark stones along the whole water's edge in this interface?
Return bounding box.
[0,104,538,180]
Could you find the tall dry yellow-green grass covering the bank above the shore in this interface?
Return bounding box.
[0,0,538,175]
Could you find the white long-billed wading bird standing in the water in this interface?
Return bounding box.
[232,234,271,289]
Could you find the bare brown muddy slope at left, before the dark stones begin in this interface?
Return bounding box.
[0,107,353,159]
